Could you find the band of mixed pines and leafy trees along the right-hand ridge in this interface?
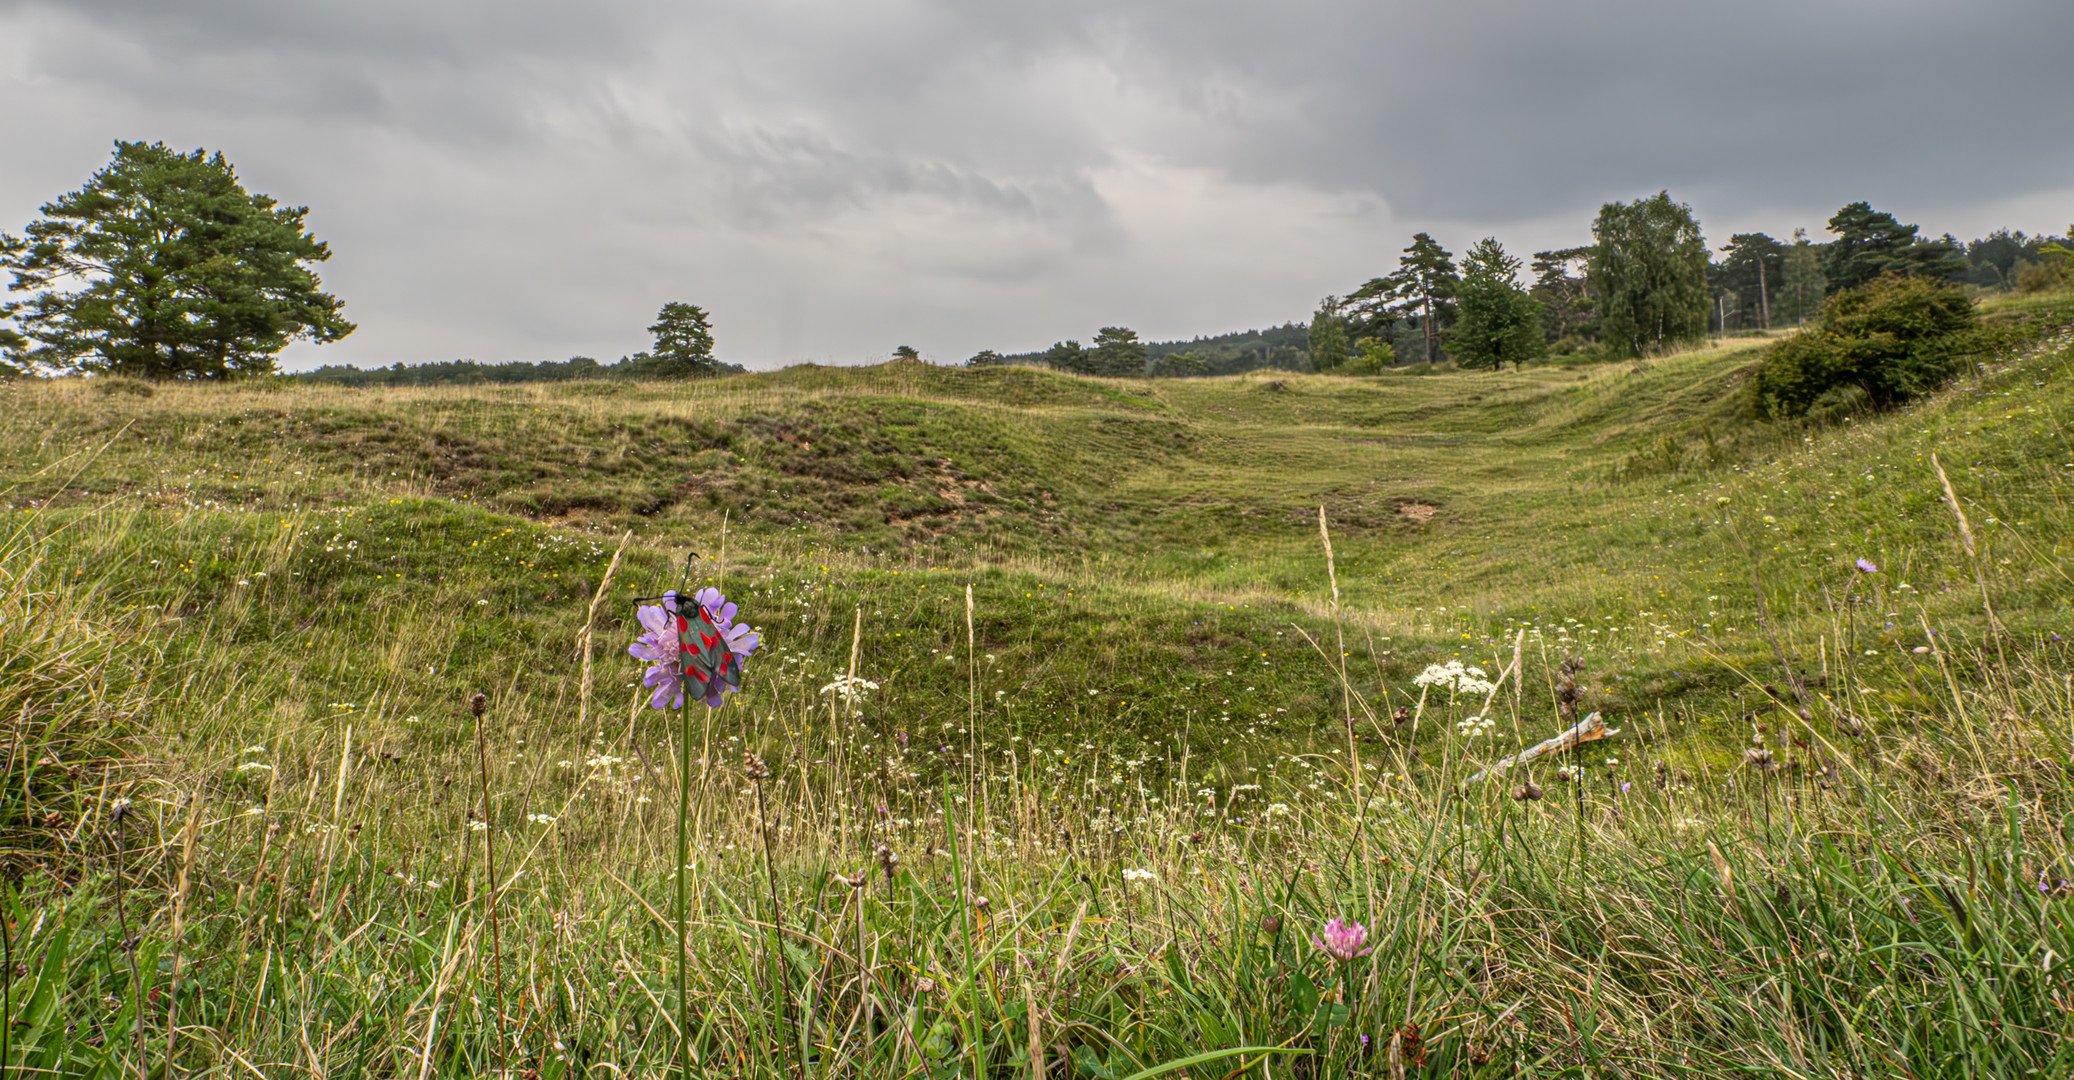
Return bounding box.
[1309,191,2074,371]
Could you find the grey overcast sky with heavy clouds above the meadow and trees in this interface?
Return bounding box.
[0,0,2074,369]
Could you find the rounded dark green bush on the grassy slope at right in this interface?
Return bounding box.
[1753,276,1977,419]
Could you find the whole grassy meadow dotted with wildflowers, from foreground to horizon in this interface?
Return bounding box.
[0,296,2074,1080]
